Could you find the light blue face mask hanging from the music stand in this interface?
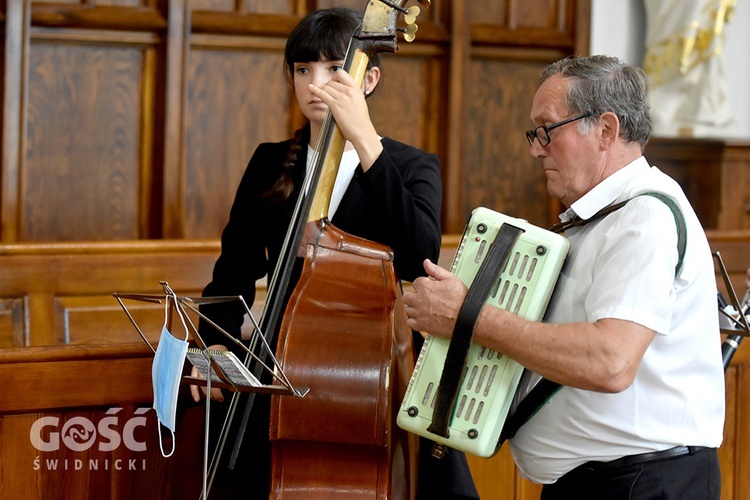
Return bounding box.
[151,299,188,457]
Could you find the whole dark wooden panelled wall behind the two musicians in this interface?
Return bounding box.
[0,0,589,243]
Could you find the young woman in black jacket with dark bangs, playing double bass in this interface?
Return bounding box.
[191,8,476,498]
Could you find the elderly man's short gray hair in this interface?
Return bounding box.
[539,55,651,150]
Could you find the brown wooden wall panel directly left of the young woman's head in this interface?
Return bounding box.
[184,43,291,238]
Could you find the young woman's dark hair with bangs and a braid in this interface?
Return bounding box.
[262,7,380,202]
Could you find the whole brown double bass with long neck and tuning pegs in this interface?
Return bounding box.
[206,0,428,499]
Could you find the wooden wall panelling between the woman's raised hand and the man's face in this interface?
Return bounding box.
[443,0,589,233]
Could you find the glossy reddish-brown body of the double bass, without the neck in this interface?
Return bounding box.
[270,220,417,498]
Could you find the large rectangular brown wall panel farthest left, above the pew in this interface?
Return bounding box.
[21,43,144,241]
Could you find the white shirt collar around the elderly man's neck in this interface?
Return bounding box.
[560,156,651,221]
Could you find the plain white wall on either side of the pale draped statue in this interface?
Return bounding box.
[590,0,750,139]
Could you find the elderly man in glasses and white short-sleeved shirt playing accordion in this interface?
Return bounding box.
[404,52,724,500]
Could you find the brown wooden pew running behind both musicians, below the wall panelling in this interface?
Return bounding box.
[0,231,750,500]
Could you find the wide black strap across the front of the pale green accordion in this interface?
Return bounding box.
[427,224,523,438]
